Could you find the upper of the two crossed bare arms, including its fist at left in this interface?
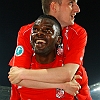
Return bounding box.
[8,64,79,84]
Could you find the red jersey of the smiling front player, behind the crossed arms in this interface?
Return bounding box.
[10,55,91,100]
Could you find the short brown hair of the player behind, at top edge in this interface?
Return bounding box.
[41,0,62,14]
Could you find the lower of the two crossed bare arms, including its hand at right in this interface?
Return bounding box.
[17,75,81,96]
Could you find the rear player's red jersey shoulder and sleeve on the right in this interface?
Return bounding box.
[62,24,87,65]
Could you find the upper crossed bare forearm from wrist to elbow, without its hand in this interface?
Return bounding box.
[21,64,79,83]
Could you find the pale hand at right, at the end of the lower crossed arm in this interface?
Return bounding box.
[63,75,82,96]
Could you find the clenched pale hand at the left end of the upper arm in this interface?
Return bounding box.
[8,67,26,84]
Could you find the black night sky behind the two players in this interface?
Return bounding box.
[0,0,100,86]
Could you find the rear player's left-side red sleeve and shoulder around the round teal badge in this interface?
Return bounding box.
[9,23,33,68]
